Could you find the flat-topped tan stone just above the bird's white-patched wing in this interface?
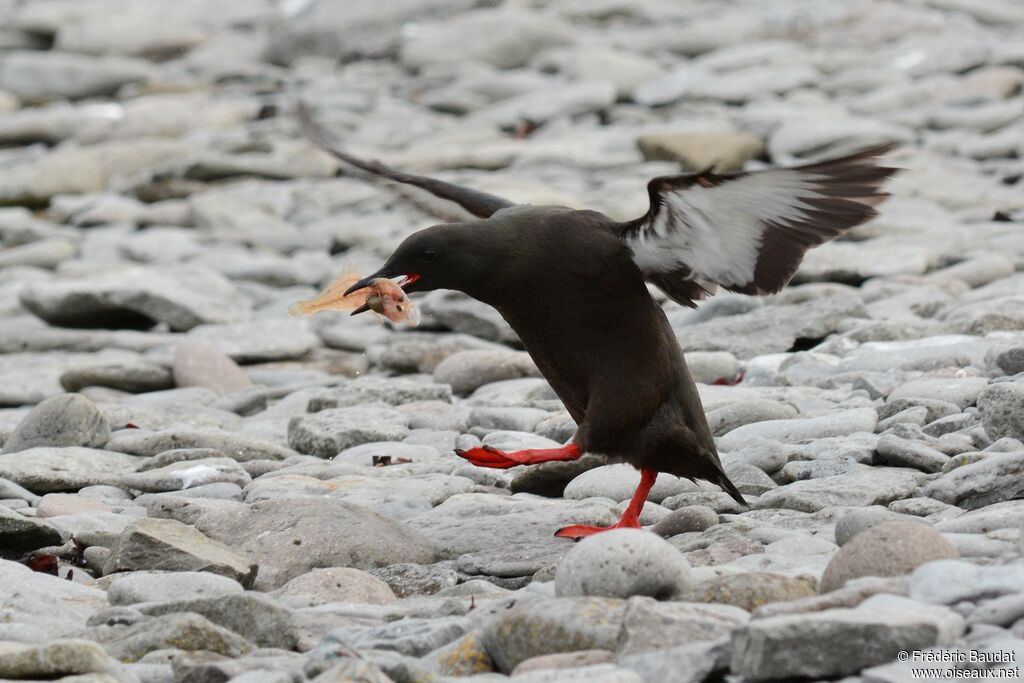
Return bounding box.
[637,133,764,173]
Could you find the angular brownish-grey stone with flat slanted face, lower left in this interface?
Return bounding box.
[103,519,257,586]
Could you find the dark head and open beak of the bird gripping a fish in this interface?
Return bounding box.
[345,223,500,305]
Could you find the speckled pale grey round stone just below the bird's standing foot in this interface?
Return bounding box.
[555,528,690,600]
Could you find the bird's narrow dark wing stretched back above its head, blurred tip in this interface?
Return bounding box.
[296,101,514,218]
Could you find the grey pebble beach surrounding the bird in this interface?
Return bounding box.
[0,0,1024,683]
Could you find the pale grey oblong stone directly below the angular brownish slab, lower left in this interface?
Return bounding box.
[106,571,245,605]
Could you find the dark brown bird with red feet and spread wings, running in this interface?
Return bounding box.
[298,101,895,539]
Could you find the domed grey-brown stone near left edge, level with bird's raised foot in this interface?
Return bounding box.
[3,393,111,453]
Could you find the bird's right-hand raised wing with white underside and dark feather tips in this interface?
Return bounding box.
[620,145,897,306]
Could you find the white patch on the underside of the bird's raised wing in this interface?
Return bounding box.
[627,170,822,287]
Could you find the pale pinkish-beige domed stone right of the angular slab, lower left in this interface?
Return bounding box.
[273,567,396,607]
